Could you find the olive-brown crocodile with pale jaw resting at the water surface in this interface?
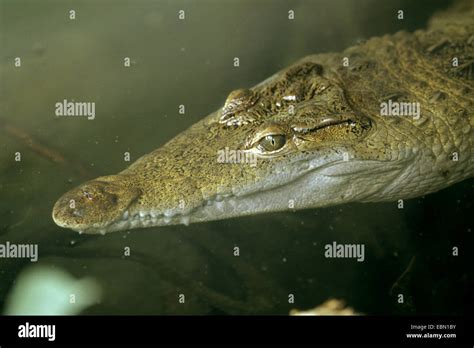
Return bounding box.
[52,1,474,234]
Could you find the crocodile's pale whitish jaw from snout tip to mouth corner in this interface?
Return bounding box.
[53,152,407,234]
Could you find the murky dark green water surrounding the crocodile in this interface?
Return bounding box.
[0,0,474,314]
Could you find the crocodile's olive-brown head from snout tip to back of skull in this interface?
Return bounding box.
[53,61,416,233]
